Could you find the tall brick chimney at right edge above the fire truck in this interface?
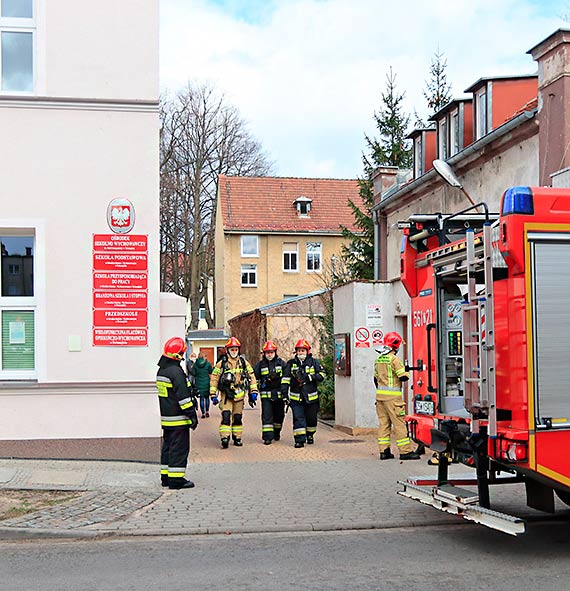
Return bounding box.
[527,29,570,186]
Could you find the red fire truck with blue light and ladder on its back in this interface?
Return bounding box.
[399,187,570,535]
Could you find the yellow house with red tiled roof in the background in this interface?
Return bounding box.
[215,176,362,327]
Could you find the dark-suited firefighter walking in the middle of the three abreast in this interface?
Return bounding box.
[253,341,285,445]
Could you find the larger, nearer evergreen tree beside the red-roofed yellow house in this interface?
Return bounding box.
[341,68,412,280]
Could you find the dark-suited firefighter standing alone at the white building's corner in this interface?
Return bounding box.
[156,337,198,489]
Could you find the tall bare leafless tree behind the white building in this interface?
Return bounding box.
[160,83,272,328]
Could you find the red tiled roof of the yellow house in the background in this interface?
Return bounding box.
[215,175,362,233]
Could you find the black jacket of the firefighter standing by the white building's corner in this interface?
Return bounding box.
[156,355,198,429]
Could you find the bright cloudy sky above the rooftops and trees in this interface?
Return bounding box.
[160,0,570,178]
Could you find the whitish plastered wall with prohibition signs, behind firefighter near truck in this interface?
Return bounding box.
[333,282,407,434]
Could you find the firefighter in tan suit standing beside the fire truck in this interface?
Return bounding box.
[374,332,420,460]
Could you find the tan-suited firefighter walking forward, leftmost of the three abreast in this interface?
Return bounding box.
[210,337,257,449]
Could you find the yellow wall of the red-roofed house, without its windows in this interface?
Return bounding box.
[216,234,346,327]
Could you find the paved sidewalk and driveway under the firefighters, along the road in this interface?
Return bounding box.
[0,409,564,539]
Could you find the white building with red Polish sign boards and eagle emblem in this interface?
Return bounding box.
[0,0,184,457]
